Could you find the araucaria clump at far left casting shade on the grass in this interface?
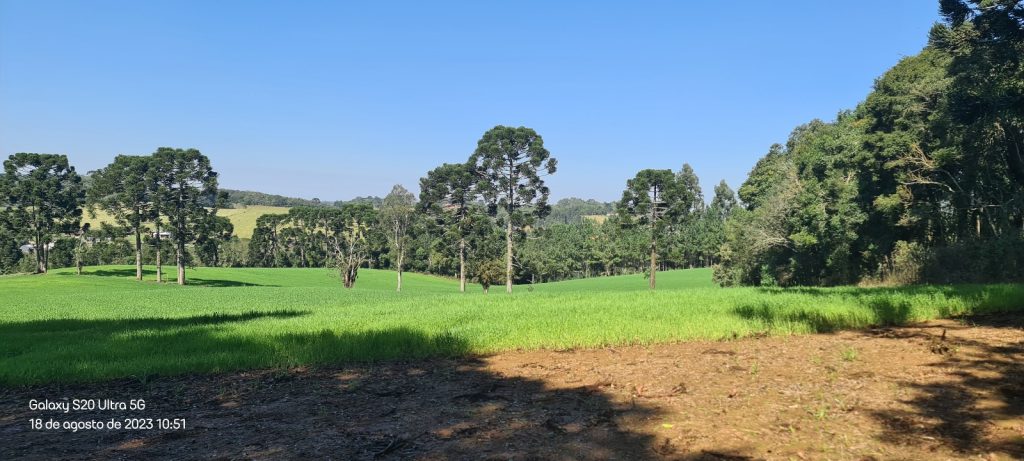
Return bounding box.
[0,148,224,285]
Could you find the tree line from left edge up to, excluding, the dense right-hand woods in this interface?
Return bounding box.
[0,126,736,291]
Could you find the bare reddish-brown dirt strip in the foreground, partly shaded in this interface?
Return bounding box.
[0,316,1024,460]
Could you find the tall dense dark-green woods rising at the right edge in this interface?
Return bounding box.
[715,0,1024,286]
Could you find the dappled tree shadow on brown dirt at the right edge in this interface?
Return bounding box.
[865,313,1024,459]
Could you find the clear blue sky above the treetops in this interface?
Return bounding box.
[0,0,939,201]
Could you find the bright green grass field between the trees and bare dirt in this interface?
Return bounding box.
[0,266,1024,385]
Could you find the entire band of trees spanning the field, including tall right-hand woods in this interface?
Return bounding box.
[0,0,1024,290]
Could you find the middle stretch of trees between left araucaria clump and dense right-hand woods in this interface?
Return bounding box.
[240,126,736,291]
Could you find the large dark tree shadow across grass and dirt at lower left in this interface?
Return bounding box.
[0,319,750,460]
